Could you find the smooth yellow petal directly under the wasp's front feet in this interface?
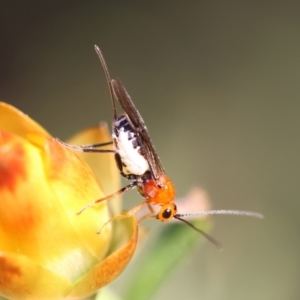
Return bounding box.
[25,134,111,259]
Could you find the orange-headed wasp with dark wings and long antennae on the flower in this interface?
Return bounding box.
[56,46,262,247]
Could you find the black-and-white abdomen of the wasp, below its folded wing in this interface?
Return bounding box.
[112,115,149,179]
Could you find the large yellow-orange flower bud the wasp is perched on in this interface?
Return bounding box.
[0,102,137,300]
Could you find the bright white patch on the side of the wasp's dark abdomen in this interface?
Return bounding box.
[112,127,149,175]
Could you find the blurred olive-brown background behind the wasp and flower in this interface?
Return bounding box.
[0,0,300,300]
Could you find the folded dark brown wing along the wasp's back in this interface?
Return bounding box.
[111,79,164,179]
